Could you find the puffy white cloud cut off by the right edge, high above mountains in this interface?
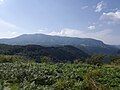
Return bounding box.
[100,11,120,23]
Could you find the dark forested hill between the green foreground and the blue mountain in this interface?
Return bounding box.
[0,44,89,62]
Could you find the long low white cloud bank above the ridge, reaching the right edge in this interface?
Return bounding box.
[48,28,120,44]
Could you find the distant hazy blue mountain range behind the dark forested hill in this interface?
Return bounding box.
[0,34,119,54]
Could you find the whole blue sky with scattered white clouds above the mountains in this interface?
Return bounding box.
[0,0,120,44]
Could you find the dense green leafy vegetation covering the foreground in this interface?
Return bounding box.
[0,55,120,90]
